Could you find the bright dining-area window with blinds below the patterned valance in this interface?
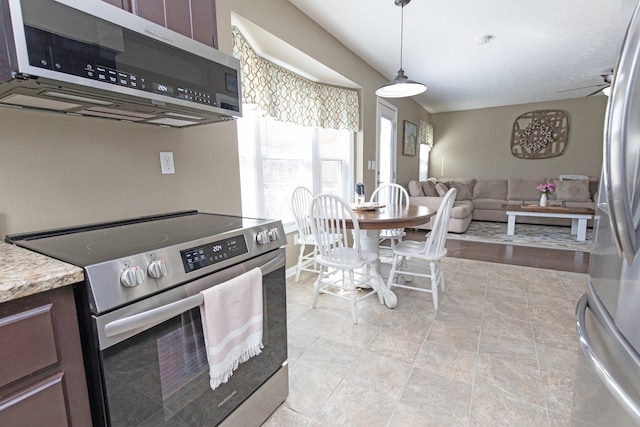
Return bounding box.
[238,105,353,231]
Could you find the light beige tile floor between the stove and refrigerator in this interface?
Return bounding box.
[264,258,586,427]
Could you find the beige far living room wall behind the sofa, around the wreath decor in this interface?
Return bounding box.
[429,96,607,178]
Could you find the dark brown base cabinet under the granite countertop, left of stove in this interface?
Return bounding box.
[0,286,91,427]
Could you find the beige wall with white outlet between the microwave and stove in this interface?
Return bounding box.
[0,108,240,235]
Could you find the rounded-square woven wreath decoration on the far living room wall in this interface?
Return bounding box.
[511,110,569,159]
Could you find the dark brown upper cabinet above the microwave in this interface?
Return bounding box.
[103,0,218,48]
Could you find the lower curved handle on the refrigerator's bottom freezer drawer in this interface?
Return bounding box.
[576,294,640,425]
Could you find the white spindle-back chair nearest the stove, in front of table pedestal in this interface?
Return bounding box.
[310,194,396,324]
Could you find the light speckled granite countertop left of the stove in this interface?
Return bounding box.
[0,242,84,303]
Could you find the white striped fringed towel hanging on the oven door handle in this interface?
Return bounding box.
[200,268,263,390]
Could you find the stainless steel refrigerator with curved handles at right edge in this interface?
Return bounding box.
[572,1,640,427]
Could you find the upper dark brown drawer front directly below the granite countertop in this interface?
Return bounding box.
[0,304,58,387]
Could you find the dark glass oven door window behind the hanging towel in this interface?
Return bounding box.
[102,268,287,427]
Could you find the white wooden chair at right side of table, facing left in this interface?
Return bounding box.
[387,188,456,310]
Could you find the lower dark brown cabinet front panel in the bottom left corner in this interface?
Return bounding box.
[0,372,69,427]
